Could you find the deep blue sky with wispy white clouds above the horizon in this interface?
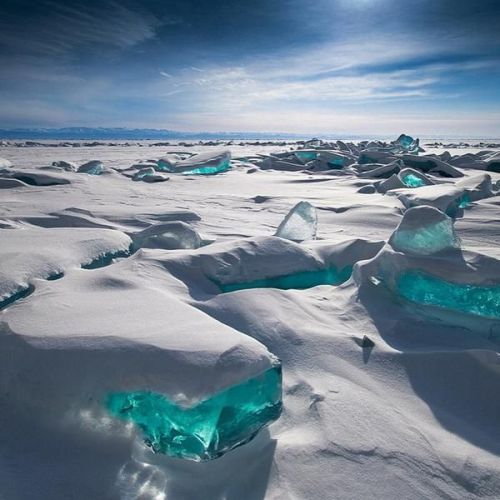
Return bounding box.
[0,0,500,138]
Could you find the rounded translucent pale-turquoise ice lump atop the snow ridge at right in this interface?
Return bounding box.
[389,206,460,255]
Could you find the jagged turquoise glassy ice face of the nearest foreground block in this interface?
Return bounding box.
[106,361,282,461]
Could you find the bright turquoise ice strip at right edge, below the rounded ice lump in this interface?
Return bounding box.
[396,271,500,318]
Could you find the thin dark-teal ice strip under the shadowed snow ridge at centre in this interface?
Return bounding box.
[218,266,352,293]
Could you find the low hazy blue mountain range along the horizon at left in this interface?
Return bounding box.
[0,127,316,141]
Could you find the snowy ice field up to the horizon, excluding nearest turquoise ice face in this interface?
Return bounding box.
[0,136,500,500]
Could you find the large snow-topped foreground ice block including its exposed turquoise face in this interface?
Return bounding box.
[0,258,281,460]
